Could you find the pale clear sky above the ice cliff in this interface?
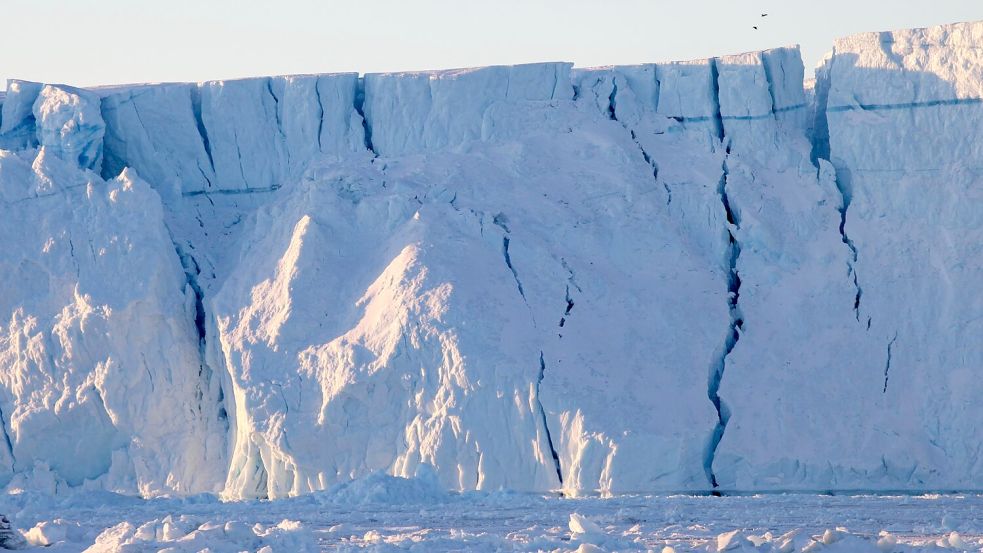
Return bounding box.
[0,0,983,86]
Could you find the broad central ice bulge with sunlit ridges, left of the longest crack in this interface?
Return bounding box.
[216,62,727,496]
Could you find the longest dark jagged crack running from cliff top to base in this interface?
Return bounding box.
[703,60,744,495]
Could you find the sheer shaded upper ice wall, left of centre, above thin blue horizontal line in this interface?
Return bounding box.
[102,74,363,200]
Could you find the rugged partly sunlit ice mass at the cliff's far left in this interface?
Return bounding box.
[0,148,225,495]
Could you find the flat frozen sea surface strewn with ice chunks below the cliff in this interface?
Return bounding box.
[6,475,983,552]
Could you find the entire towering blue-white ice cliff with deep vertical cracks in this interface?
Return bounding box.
[0,23,983,498]
